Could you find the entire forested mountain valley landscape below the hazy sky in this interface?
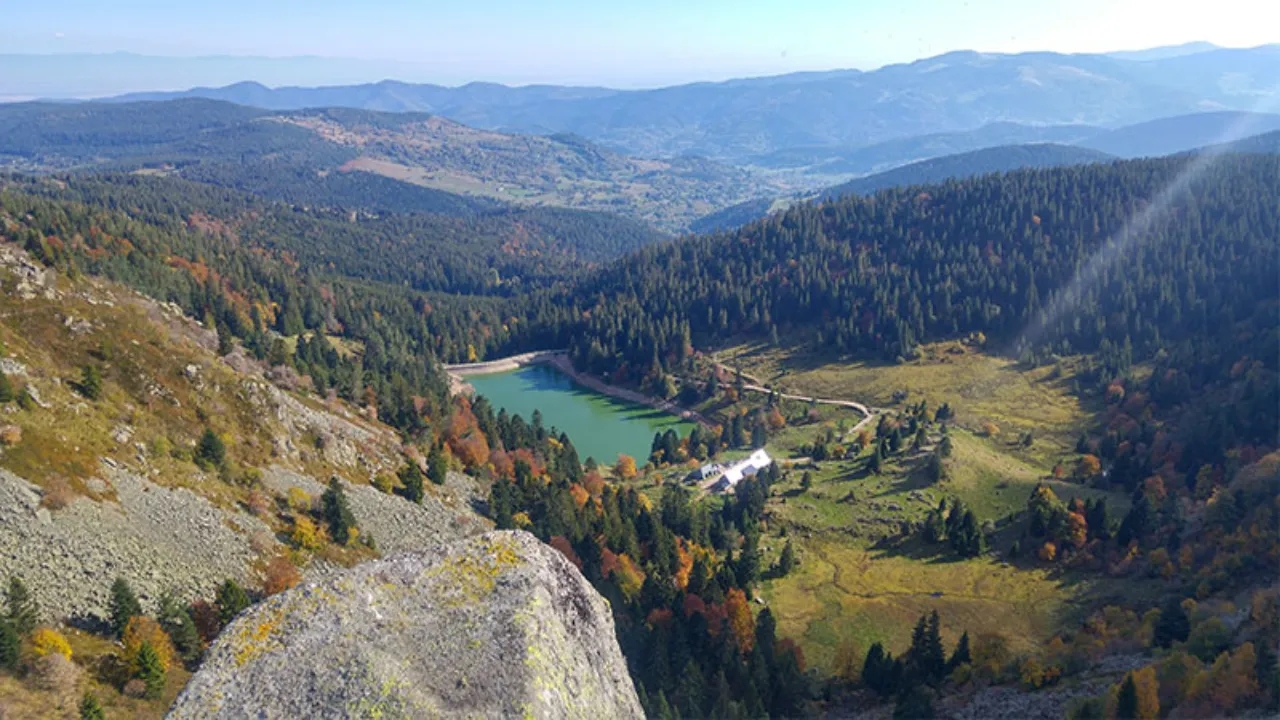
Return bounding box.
[0,40,1280,720]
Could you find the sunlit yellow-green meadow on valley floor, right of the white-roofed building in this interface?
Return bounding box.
[716,342,1133,670]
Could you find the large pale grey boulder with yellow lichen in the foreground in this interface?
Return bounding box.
[169,532,643,720]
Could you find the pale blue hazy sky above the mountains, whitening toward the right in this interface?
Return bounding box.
[0,0,1280,86]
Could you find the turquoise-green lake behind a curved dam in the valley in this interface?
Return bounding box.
[465,365,694,465]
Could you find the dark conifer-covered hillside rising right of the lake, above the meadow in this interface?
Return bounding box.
[547,156,1280,372]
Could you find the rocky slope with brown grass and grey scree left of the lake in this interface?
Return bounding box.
[0,240,485,626]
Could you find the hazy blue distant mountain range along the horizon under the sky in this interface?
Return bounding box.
[85,45,1280,164]
